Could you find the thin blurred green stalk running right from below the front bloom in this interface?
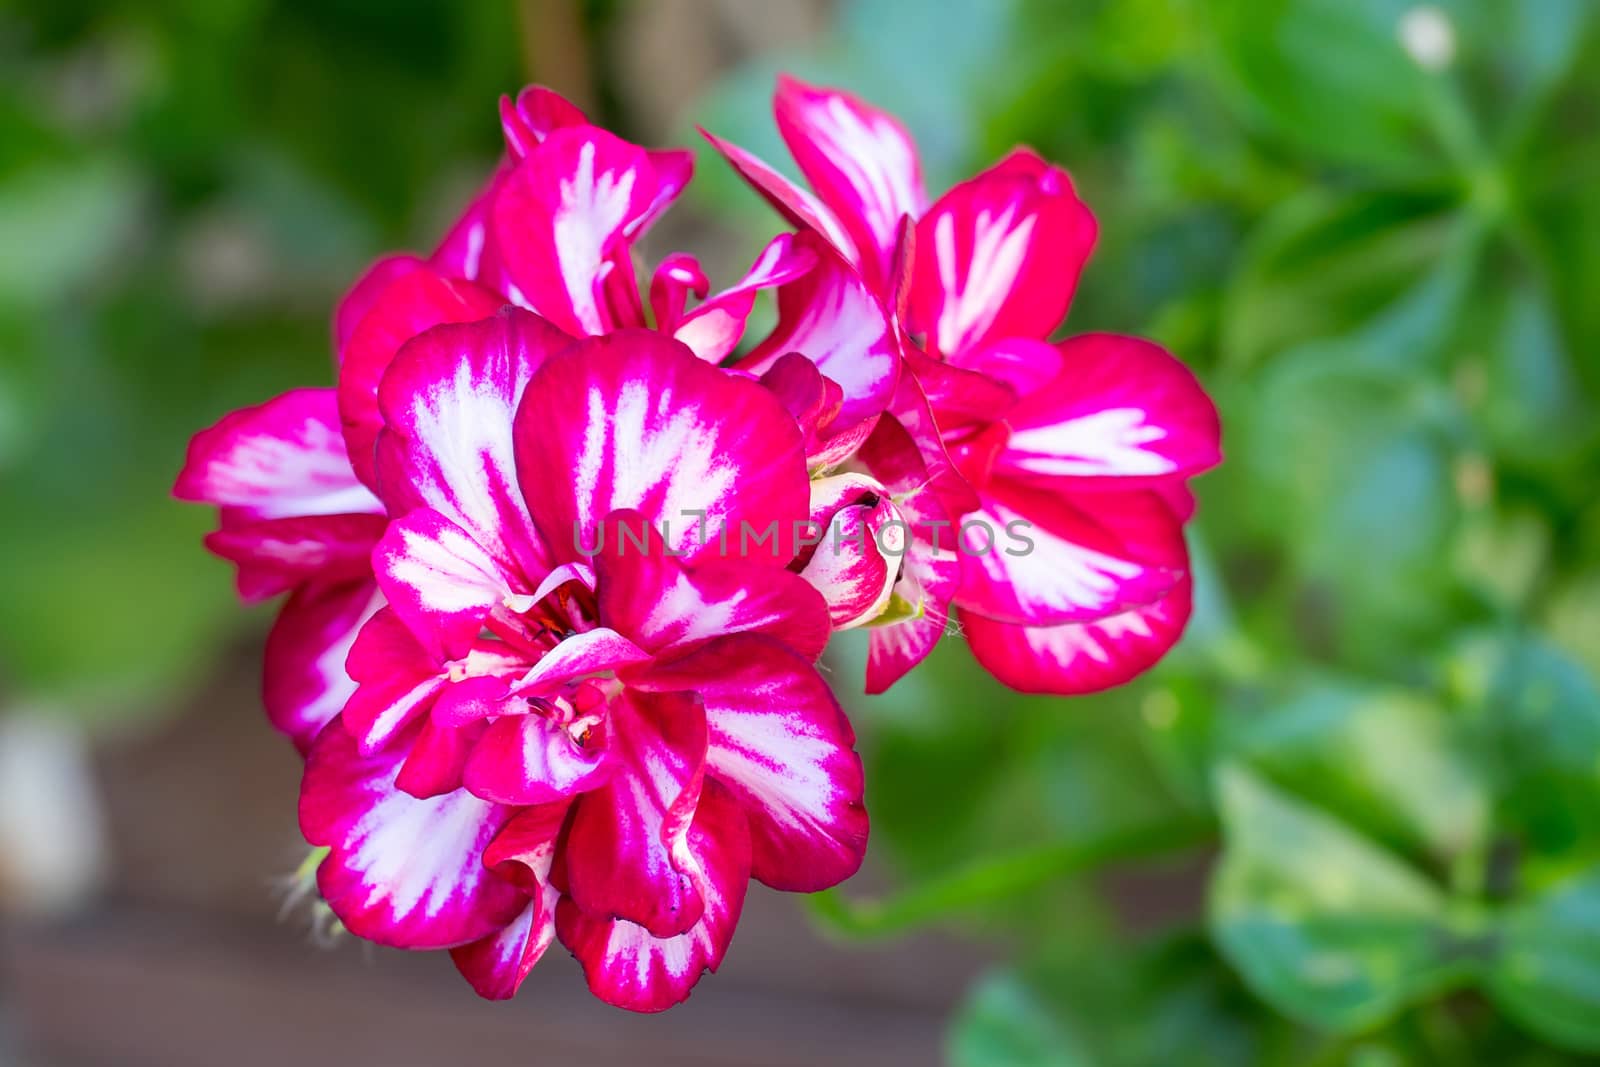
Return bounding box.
[806,816,1216,939]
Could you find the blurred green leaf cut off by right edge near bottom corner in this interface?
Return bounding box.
[1488,870,1600,1053]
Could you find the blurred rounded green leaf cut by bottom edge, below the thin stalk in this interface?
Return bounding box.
[949,971,1093,1067]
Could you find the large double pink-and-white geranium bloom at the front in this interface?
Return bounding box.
[301,309,867,1011]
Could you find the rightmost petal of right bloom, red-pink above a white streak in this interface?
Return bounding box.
[995,334,1222,488]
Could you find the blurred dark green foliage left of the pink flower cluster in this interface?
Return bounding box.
[0,0,520,721]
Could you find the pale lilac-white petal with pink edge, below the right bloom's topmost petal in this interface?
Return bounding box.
[739,234,901,426]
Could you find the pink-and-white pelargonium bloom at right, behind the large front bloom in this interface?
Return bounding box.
[707,78,1221,693]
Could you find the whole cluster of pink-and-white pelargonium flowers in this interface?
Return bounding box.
[176,80,1219,1011]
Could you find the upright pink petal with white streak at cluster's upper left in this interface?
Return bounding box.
[493,126,662,336]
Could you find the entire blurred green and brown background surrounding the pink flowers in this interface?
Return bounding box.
[0,0,1600,1067]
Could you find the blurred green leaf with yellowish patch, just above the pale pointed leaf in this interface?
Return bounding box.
[1234,681,1490,861]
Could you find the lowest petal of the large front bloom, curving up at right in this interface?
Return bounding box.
[555,781,750,1011]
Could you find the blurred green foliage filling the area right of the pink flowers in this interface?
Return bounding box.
[707,0,1600,1067]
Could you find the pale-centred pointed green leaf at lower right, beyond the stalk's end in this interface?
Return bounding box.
[1210,766,1466,1032]
